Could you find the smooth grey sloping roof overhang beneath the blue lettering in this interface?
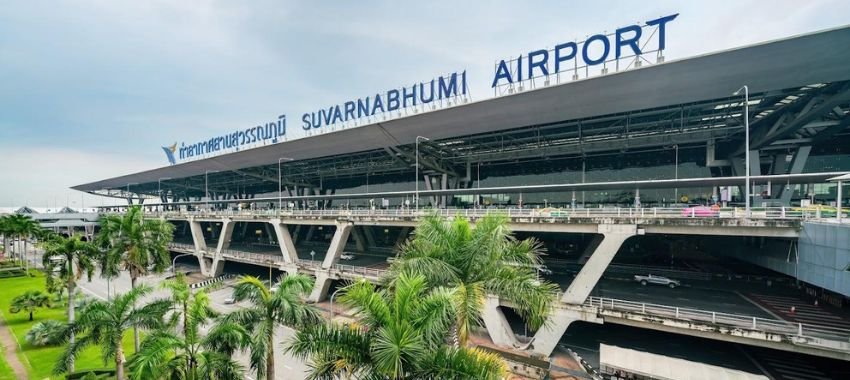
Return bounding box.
[73,27,850,192]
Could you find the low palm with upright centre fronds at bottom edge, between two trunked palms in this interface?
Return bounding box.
[128,292,249,380]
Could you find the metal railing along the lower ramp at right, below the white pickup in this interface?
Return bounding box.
[585,297,850,348]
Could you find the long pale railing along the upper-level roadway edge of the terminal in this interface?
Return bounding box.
[148,207,835,220]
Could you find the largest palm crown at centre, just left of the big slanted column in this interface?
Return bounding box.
[388,214,558,346]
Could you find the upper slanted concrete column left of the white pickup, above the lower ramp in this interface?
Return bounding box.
[561,224,637,305]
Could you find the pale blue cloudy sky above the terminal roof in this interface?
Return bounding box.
[0,0,850,207]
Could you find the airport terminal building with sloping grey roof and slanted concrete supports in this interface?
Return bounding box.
[74,19,850,378]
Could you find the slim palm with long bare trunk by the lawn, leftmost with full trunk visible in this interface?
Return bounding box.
[42,234,99,372]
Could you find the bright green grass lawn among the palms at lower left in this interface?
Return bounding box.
[0,274,134,380]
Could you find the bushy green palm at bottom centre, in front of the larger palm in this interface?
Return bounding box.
[287,273,506,380]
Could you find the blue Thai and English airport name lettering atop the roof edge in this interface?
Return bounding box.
[162,13,679,165]
